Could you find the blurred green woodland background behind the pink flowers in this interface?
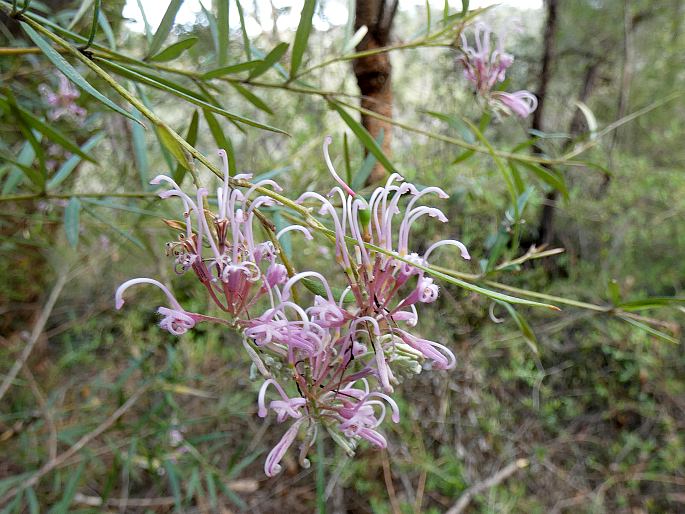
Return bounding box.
[0,0,685,513]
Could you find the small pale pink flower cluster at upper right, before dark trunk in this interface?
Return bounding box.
[460,23,538,118]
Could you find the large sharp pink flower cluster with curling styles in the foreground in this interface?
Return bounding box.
[116,138,469,476]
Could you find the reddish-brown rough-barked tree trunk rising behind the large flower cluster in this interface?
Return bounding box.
[353,0,399,184]
